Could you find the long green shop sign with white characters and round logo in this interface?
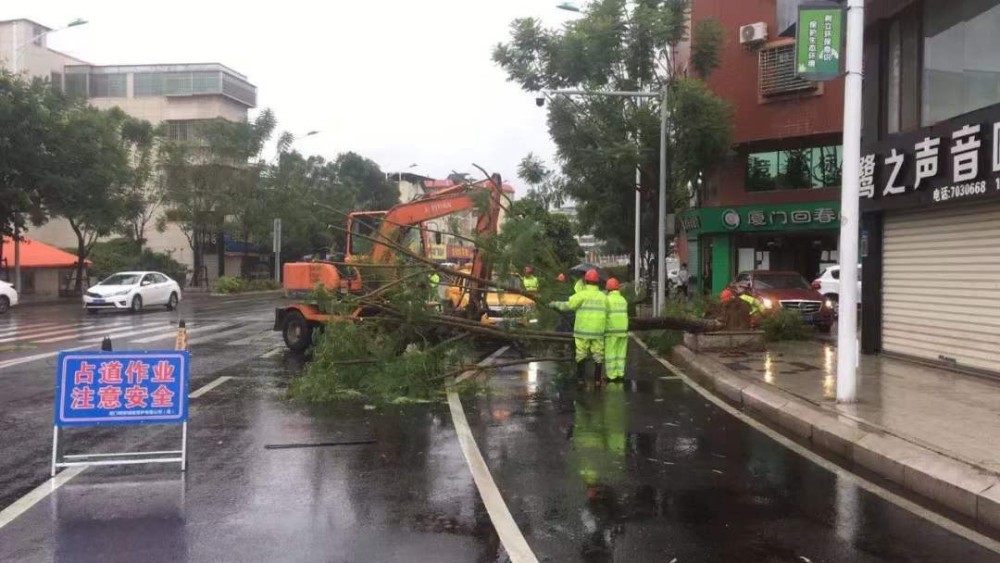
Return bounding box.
[681,201,840,238]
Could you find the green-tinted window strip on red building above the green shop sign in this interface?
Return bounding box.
[746,146,843,192]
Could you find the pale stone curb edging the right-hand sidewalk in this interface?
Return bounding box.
[650,340,1000,530]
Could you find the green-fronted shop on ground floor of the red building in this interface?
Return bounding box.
[681,201,840,295]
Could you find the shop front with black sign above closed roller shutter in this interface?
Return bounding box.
[861,105,1000,373]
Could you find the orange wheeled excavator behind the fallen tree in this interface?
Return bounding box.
[274,174,503,351]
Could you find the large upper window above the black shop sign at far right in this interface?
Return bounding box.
[922,0,1000,125]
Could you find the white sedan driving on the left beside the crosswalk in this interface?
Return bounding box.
[83,272,181,313]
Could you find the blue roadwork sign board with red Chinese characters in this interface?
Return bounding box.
[55,351,191,427]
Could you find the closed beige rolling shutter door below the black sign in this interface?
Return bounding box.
[882,203,1000,372]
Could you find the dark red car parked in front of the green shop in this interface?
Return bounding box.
[734,270,834,333]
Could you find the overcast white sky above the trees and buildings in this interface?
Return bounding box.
[0,0,574,194]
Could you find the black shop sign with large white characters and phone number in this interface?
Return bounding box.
[859,104,1000,209]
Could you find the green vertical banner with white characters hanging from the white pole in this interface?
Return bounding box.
[795,6,844,81]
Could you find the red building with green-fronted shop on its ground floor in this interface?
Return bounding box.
[679,0,844,294]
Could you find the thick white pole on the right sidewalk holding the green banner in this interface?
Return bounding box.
[837,0,865,403]
